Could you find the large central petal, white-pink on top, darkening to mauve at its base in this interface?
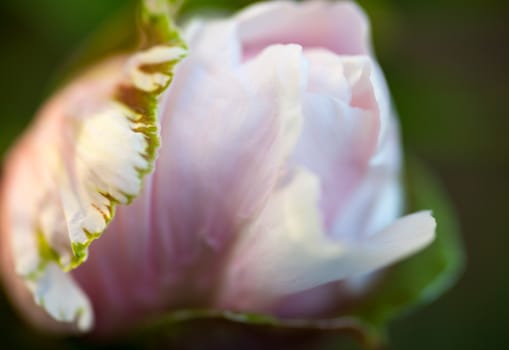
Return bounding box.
[70,44,307,330]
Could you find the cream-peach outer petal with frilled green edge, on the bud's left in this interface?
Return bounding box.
[2,1,185,330]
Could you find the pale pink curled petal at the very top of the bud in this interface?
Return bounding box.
[236,1,370,58]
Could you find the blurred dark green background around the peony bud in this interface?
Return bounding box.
[0,0,509,350]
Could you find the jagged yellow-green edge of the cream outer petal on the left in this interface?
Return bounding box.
[33,0,187,279]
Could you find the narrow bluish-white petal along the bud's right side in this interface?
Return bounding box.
[328,57,403,240]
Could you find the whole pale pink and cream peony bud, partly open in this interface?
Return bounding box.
[1,1,435,333]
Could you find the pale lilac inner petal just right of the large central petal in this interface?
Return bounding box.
[293,50,380,234]
